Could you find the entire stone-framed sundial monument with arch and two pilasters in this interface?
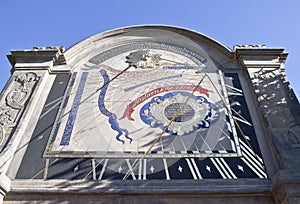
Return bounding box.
[0,25,300,203]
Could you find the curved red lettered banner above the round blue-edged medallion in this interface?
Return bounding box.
[120,85,212,121]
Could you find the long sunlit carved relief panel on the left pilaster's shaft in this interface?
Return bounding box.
[0,72,39,150]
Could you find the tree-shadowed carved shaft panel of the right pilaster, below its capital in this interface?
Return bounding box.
[248,64,300,169]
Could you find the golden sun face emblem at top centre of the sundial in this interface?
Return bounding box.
[126,50,161,68]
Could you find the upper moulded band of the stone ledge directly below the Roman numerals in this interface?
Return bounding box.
[11,179,271,197]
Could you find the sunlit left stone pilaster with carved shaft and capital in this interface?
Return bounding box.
[0,47,67,203]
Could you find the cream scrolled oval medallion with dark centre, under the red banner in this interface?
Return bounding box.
[143,93,211,135]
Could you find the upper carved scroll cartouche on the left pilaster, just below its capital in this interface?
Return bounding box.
[6,72,38,109]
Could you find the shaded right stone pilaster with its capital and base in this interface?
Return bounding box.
[235,46,300,203]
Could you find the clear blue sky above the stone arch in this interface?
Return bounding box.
[0,0,300,98]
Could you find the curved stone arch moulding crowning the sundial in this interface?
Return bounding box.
[64,25,236,70]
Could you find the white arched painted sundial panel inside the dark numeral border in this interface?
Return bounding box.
[46,43,239,163]
